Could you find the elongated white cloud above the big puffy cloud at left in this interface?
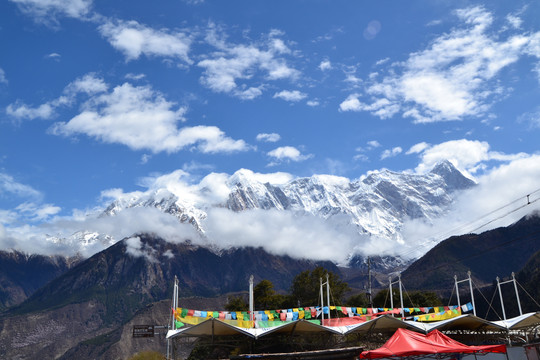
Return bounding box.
[99,20,191,64]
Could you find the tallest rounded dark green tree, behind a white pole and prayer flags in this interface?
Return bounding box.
[287,266,350,306]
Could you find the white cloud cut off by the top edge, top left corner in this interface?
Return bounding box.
[10,0,93,23]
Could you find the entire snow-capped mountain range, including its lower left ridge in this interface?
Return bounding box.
[86,161,475,253]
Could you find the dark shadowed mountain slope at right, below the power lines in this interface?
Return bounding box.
[402,213,540,289]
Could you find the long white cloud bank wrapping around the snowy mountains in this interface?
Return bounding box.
[0,140,540,263]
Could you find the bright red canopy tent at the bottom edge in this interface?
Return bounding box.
[360,329,506,359]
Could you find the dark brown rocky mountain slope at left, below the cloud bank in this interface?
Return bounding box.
[0,235,339,359]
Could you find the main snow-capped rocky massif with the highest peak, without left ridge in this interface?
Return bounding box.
[225,161,475,240]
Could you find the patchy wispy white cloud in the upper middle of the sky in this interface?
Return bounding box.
[197,25,299,99]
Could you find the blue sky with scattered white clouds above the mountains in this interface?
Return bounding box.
[0,0,540,258]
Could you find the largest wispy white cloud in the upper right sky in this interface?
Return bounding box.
[340,7,536,122]
